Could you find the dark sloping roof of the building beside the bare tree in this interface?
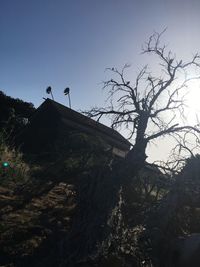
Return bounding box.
[36,98,131,148]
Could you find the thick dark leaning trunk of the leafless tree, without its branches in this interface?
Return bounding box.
[62,116,148,267]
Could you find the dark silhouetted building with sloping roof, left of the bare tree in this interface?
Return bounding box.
[17,99,131,157]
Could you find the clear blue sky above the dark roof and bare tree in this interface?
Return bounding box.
[0,0,200,161]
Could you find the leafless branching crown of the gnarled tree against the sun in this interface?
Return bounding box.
[86,32,200,169]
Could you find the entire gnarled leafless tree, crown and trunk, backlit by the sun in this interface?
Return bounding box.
[74,33,200,266]
